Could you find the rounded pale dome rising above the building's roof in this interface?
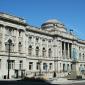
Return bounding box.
[41,19,66,32]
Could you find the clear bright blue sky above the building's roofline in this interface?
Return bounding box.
[0,0,85,40]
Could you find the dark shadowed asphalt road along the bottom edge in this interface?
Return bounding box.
[0,81,85,85]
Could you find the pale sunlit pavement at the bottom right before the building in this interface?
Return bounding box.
[48,78,85,84]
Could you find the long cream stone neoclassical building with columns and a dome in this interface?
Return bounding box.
[0,13,85,78]
